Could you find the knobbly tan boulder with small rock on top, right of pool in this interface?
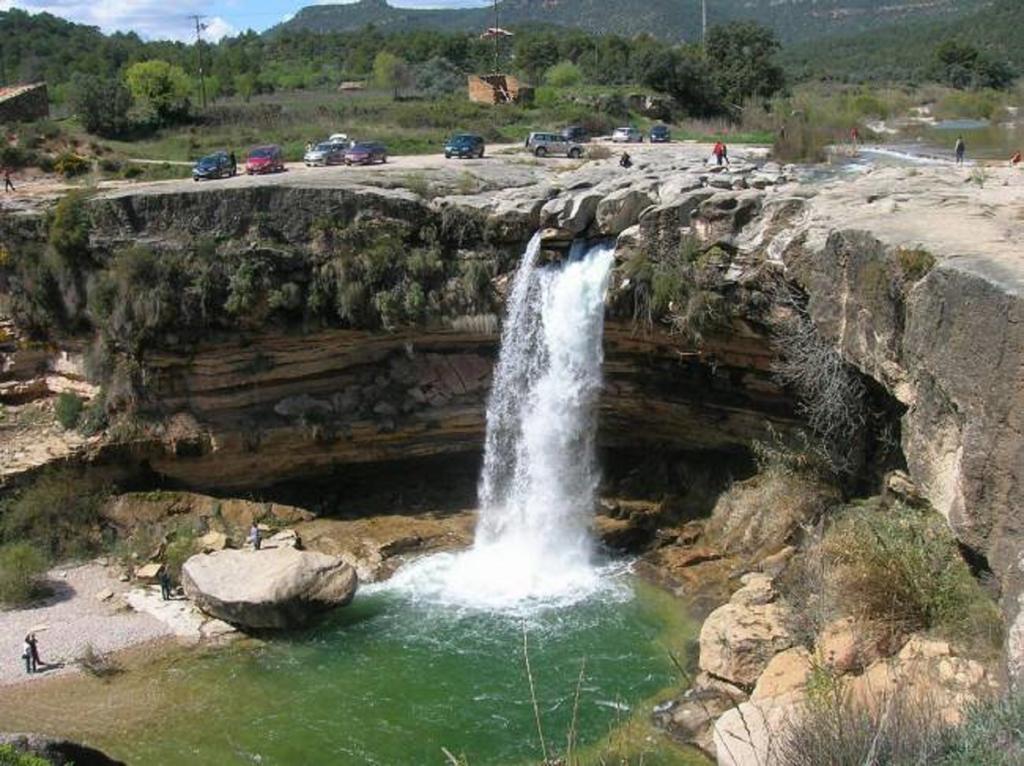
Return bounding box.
[700,573,796,688]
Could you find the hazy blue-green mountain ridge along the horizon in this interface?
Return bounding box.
[268,0,989,42]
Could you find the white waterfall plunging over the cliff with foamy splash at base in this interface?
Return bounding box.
[382,235,612,609]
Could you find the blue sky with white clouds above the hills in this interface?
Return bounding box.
[0,0,480,40]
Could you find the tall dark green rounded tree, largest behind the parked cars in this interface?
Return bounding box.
[705,22,785,110]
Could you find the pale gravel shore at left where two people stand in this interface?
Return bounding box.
[0,562,174,686]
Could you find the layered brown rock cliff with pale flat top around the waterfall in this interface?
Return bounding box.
[0,147,1024,675]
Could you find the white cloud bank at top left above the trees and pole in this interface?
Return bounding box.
[0,0,236,41]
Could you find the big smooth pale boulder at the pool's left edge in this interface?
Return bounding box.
[181,547,357,629]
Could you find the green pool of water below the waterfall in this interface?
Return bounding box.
[96,580,699,766]
